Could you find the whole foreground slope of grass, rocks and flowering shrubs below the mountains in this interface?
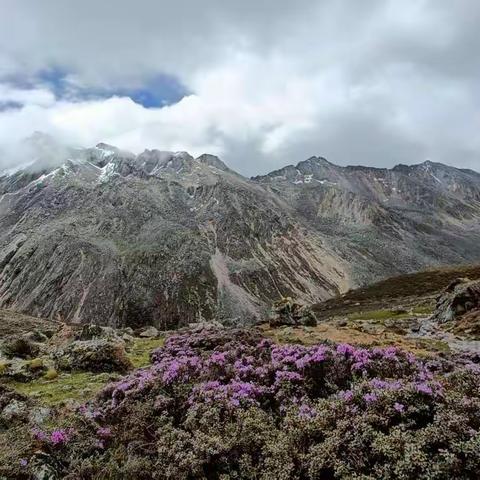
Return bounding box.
[0,267,480,480]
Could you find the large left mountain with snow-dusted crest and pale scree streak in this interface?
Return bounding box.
[0,139,348,328]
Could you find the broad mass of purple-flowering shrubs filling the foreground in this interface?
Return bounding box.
[16,329,480,480]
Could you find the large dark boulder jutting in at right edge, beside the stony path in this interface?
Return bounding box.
[432,278,480,323]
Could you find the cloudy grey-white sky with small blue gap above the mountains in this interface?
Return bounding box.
[0,0,480,175]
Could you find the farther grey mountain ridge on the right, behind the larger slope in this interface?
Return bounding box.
[254,157,480,285]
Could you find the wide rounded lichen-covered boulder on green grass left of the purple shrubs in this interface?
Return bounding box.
[53,339,132,372]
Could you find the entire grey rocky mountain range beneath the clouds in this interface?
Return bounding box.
[0,139,480,328]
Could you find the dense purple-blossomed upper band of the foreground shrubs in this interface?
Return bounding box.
[89,329,438,416]
